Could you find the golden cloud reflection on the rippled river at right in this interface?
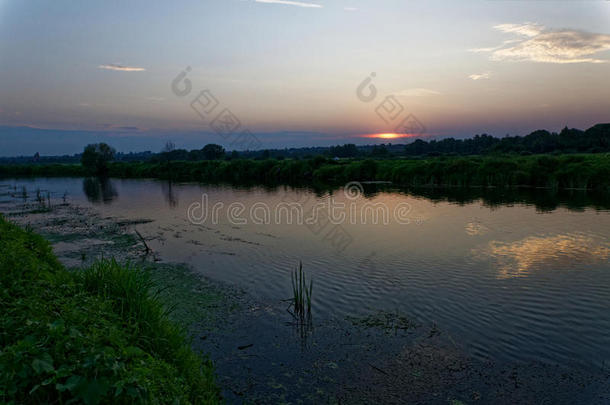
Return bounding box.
[473,233,610,278]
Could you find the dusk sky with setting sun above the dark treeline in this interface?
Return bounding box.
[0,0,610,156]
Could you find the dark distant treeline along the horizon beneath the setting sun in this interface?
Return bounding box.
[0,124,610,164]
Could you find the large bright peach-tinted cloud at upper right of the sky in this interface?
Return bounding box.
[470,23,610,63]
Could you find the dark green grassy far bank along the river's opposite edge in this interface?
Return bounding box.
[0,154,610,191]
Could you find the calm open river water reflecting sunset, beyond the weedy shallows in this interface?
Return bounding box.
[0,179,610,367]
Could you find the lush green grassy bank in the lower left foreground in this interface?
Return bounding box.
[0,216,219,403]
